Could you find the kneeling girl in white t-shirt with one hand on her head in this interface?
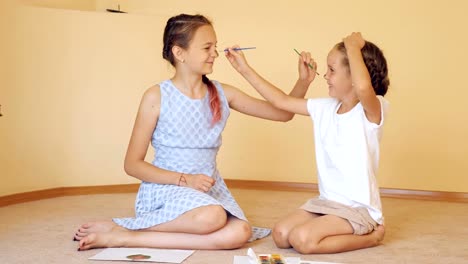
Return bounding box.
[226,32,390,254]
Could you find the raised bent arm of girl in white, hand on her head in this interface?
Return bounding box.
[343,32,381,124]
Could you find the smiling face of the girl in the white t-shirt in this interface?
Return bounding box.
[324,48,354,101]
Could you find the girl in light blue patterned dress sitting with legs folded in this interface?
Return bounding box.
[74,14,313,250]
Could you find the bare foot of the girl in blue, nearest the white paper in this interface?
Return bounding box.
[78,230,127,251]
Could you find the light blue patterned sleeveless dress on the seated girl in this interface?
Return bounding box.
[113,80,270,241]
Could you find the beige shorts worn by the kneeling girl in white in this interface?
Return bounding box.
[300,198,378,235]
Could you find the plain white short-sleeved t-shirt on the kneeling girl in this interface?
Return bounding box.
[307,96,388,224]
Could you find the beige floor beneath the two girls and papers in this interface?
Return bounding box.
[0,188,468,264]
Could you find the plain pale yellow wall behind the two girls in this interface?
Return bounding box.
[0,0,468,196]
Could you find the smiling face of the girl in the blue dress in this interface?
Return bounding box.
[183,25,218,75]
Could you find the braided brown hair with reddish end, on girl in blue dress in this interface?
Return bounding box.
[162,14,221,124]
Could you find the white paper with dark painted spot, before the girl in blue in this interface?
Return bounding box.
[89,248,195,263]
